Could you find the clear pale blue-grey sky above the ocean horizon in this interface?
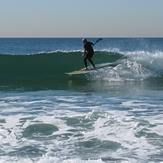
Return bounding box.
[0,0,163,38]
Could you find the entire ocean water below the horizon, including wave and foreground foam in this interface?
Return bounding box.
[0,38,163,163]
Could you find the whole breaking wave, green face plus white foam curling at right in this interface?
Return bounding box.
[0,51,163,88]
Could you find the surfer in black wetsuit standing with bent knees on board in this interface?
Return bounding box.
[82,38,95,70]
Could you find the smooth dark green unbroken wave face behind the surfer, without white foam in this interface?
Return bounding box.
[0,51,122,80]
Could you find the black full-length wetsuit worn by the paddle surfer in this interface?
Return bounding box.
[83,42,95,67]
